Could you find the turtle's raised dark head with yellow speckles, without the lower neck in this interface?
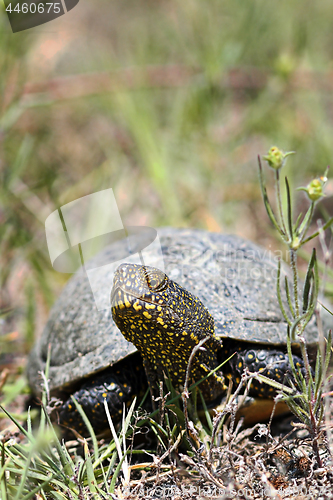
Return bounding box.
[111,264,214,365]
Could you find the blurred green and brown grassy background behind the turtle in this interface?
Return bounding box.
[0,0,333,398]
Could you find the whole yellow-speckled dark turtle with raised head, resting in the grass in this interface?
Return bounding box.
[27,227,325,434]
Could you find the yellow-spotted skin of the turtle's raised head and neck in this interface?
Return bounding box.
[111,264,226,402]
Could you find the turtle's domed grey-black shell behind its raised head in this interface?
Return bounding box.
[28,228,324,393]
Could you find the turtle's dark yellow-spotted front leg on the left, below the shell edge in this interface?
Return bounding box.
[58,362,147,435]
